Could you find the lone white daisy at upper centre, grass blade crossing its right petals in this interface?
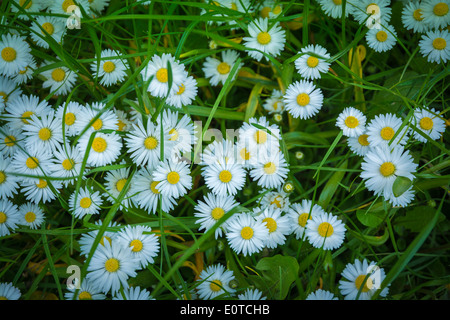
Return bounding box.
[202,50,244,86]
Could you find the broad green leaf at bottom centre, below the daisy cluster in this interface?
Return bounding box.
[255,254,299,300]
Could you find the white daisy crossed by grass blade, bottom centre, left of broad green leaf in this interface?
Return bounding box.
[197,264,235,300]
